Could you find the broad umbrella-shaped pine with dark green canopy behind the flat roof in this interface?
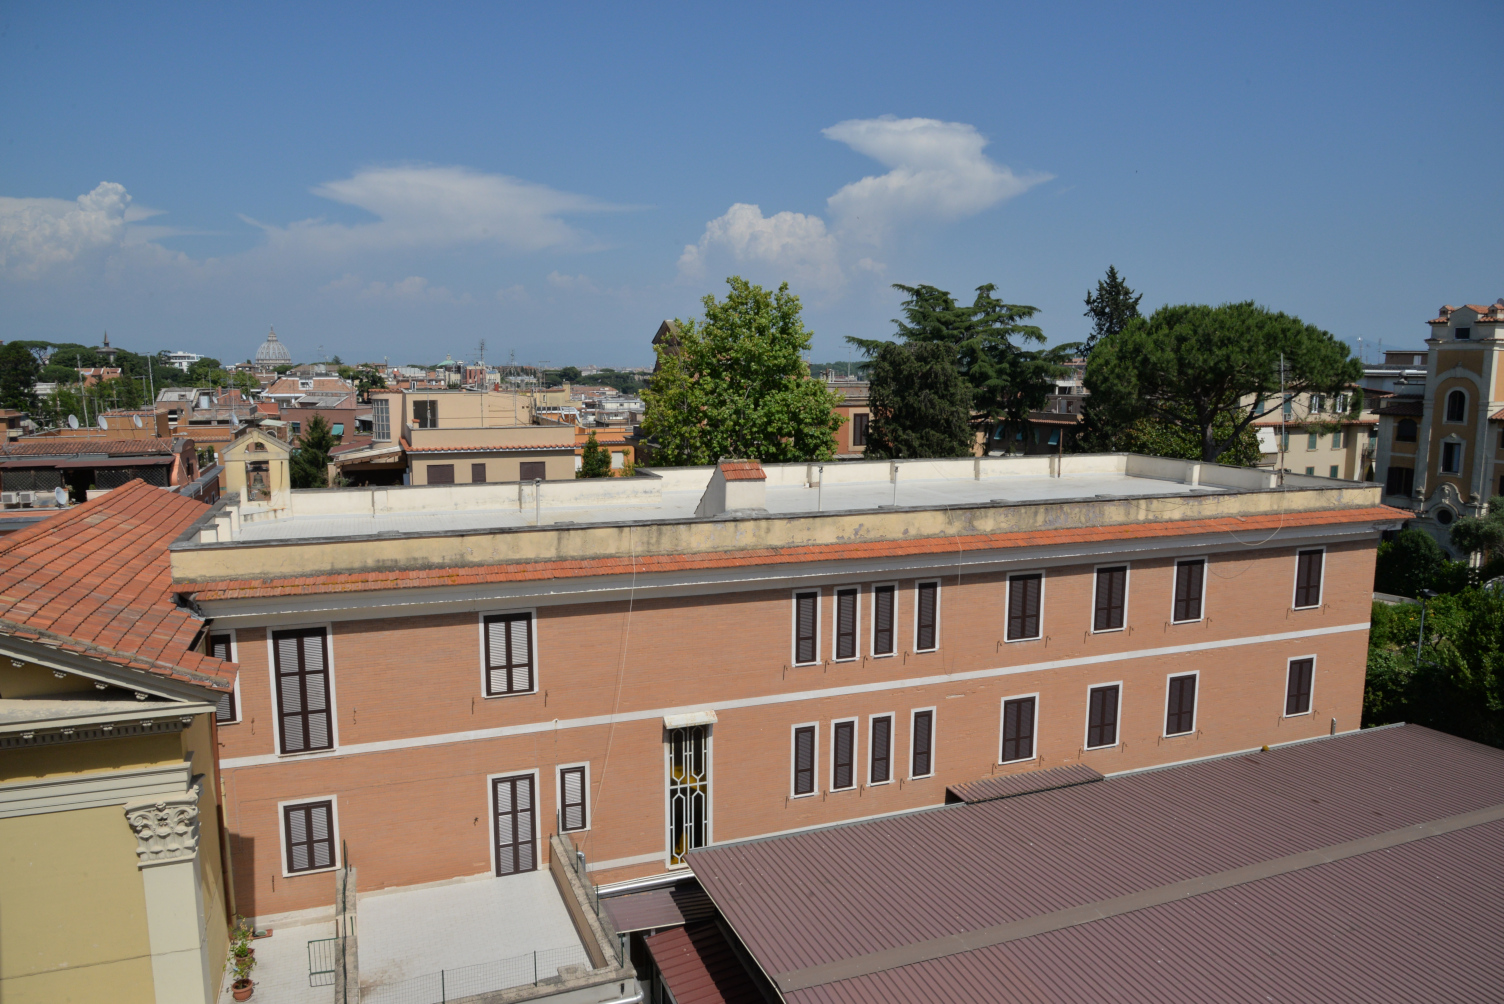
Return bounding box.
[1086,301,1363,461]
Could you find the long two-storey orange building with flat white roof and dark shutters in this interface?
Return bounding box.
[171,450,1402,931]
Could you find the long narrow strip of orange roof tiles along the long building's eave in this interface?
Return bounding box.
[174,505,1409,601]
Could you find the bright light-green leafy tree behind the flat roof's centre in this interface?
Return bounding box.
[642,275,842,466]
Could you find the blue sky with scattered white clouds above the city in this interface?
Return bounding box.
[0,0,1504,367]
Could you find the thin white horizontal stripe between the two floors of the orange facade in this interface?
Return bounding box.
[220,621,1369,770]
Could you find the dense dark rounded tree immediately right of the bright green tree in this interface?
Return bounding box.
[866,341,973,460]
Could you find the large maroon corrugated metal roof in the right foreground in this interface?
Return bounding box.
[689,726,1504,1004]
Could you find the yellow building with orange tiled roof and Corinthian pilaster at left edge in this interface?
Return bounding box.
[0,481,235,1004]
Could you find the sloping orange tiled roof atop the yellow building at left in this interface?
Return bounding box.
[0,481,236,690]
